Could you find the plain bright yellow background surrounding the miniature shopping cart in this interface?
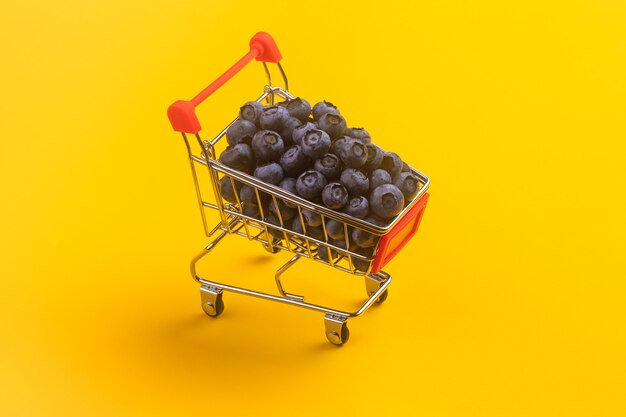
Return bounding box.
[0,0,626,417]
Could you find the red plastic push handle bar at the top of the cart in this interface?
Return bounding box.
[167,32,282,134]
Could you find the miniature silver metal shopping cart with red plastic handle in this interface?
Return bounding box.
[168,32,429,345]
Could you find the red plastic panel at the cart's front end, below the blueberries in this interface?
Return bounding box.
[372,193,430,274]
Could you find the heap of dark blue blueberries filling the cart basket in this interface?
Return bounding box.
[219,98,420,266]
